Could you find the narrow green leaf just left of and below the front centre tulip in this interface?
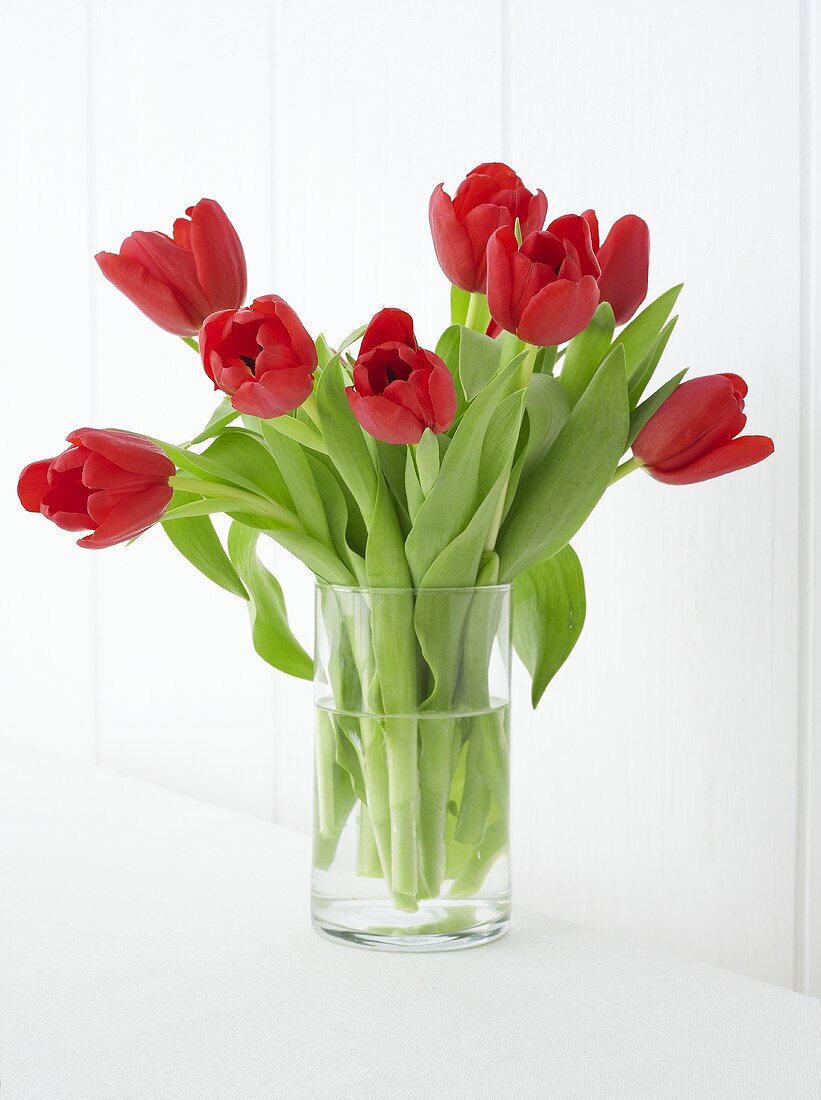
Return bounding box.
[317,359,376,524]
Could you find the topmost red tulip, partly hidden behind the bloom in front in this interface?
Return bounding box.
[429,164,547,293]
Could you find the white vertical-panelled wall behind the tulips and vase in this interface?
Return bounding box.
[0,0,821,994]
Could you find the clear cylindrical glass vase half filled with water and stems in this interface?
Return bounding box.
[311,584,511,950]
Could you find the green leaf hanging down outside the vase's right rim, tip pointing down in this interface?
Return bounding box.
[513,546,587,710]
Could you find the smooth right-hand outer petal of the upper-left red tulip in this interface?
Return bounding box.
[190,199,248,312]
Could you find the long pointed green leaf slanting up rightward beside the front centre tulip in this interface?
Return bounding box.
[405,360,517,583]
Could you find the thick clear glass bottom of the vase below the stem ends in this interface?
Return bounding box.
[311,895,511,952]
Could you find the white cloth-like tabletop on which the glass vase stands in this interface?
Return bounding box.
[0,741,821,1100]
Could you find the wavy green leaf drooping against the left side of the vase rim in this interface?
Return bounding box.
[228,523,314,680]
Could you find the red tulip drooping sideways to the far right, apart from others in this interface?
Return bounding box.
[633,374,775,485]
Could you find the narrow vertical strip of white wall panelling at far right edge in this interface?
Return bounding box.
[793,0,817,992]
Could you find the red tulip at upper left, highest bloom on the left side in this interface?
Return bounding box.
[96,199,247,337]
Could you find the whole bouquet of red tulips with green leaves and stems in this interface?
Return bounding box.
[19,164,773,937]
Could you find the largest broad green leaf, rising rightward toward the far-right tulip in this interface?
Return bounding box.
[499,347,630,581]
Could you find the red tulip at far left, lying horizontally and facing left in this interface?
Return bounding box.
[18,428,176,549]
